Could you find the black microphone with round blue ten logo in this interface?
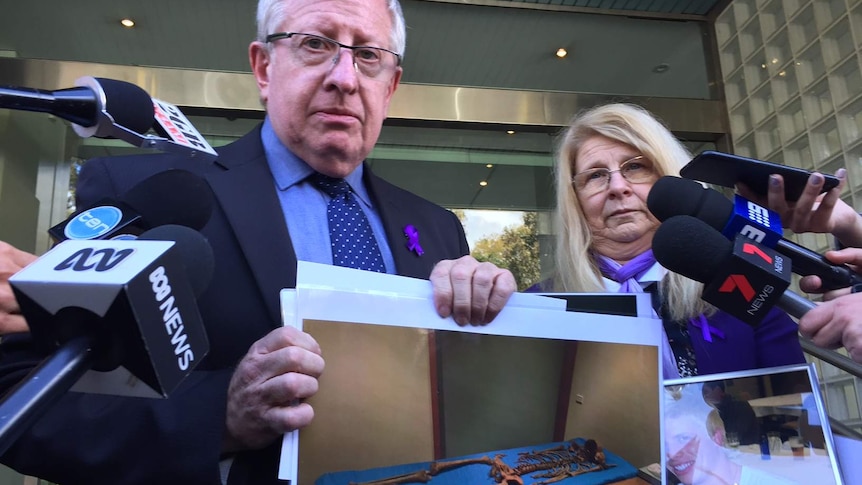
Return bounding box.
[48,169,213,242]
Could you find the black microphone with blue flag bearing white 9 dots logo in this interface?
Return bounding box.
[647,176,862,291]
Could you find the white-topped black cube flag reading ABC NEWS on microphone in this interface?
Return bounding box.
[9,240,209,397]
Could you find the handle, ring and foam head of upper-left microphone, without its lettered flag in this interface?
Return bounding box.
[0,77,154,138]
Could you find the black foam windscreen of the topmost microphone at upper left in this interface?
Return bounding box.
[95,78,155,135]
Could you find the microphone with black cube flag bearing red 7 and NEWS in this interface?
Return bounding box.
[652,215,814,325]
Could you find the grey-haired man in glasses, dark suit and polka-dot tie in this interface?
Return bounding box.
[0,0,515,484]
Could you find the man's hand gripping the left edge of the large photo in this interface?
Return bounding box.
[222,327,324,453]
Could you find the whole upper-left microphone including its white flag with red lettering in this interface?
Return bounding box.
[0,76,218,159]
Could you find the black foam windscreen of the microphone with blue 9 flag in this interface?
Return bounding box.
[647,176,733,231]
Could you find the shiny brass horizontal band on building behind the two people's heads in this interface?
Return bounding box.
[0,58,727,139]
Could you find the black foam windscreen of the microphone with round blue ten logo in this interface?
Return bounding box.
[120,169,213,230]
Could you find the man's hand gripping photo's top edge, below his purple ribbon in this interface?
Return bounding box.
[430,256,517,326]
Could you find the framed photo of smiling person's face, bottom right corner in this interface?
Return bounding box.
[662,364,843,485]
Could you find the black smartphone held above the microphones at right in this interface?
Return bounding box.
[680,150,839,201]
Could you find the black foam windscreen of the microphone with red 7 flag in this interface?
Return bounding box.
[652,215,733,283]
